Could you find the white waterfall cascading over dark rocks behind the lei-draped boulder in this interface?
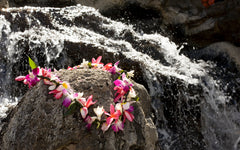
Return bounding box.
[0,5,240,150]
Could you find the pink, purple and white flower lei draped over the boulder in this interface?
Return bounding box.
[15,56,139,132]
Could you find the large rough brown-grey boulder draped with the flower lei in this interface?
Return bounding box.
[1,70,157,150]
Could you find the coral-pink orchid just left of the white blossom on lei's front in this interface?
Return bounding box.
[78,95,97,119]
